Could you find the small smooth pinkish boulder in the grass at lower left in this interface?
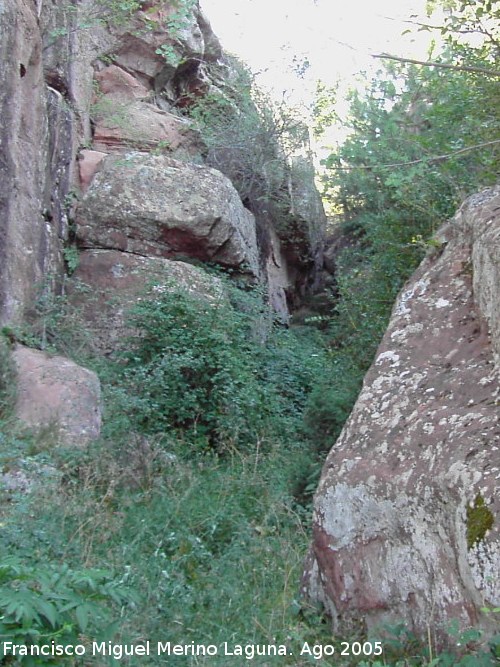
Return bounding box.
[13,345,101,446]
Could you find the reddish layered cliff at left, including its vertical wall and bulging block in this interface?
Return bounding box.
[0,0,325,323]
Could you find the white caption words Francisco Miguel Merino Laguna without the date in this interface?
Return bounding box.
[0,641,289,660]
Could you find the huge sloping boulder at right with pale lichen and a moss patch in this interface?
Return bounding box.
[305,189,500,636]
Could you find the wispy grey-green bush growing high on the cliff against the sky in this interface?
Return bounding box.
[188,56,309,251]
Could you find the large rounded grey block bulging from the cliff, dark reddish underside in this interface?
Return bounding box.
[77,153,259,276]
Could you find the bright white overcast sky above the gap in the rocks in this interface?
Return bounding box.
[200,0,429,112]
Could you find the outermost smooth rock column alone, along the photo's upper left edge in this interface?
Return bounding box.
[0,0,64,322]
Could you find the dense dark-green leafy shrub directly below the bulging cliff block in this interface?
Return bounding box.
[117,287,269,445]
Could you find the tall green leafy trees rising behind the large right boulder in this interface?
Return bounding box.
[309,2,500,452]
